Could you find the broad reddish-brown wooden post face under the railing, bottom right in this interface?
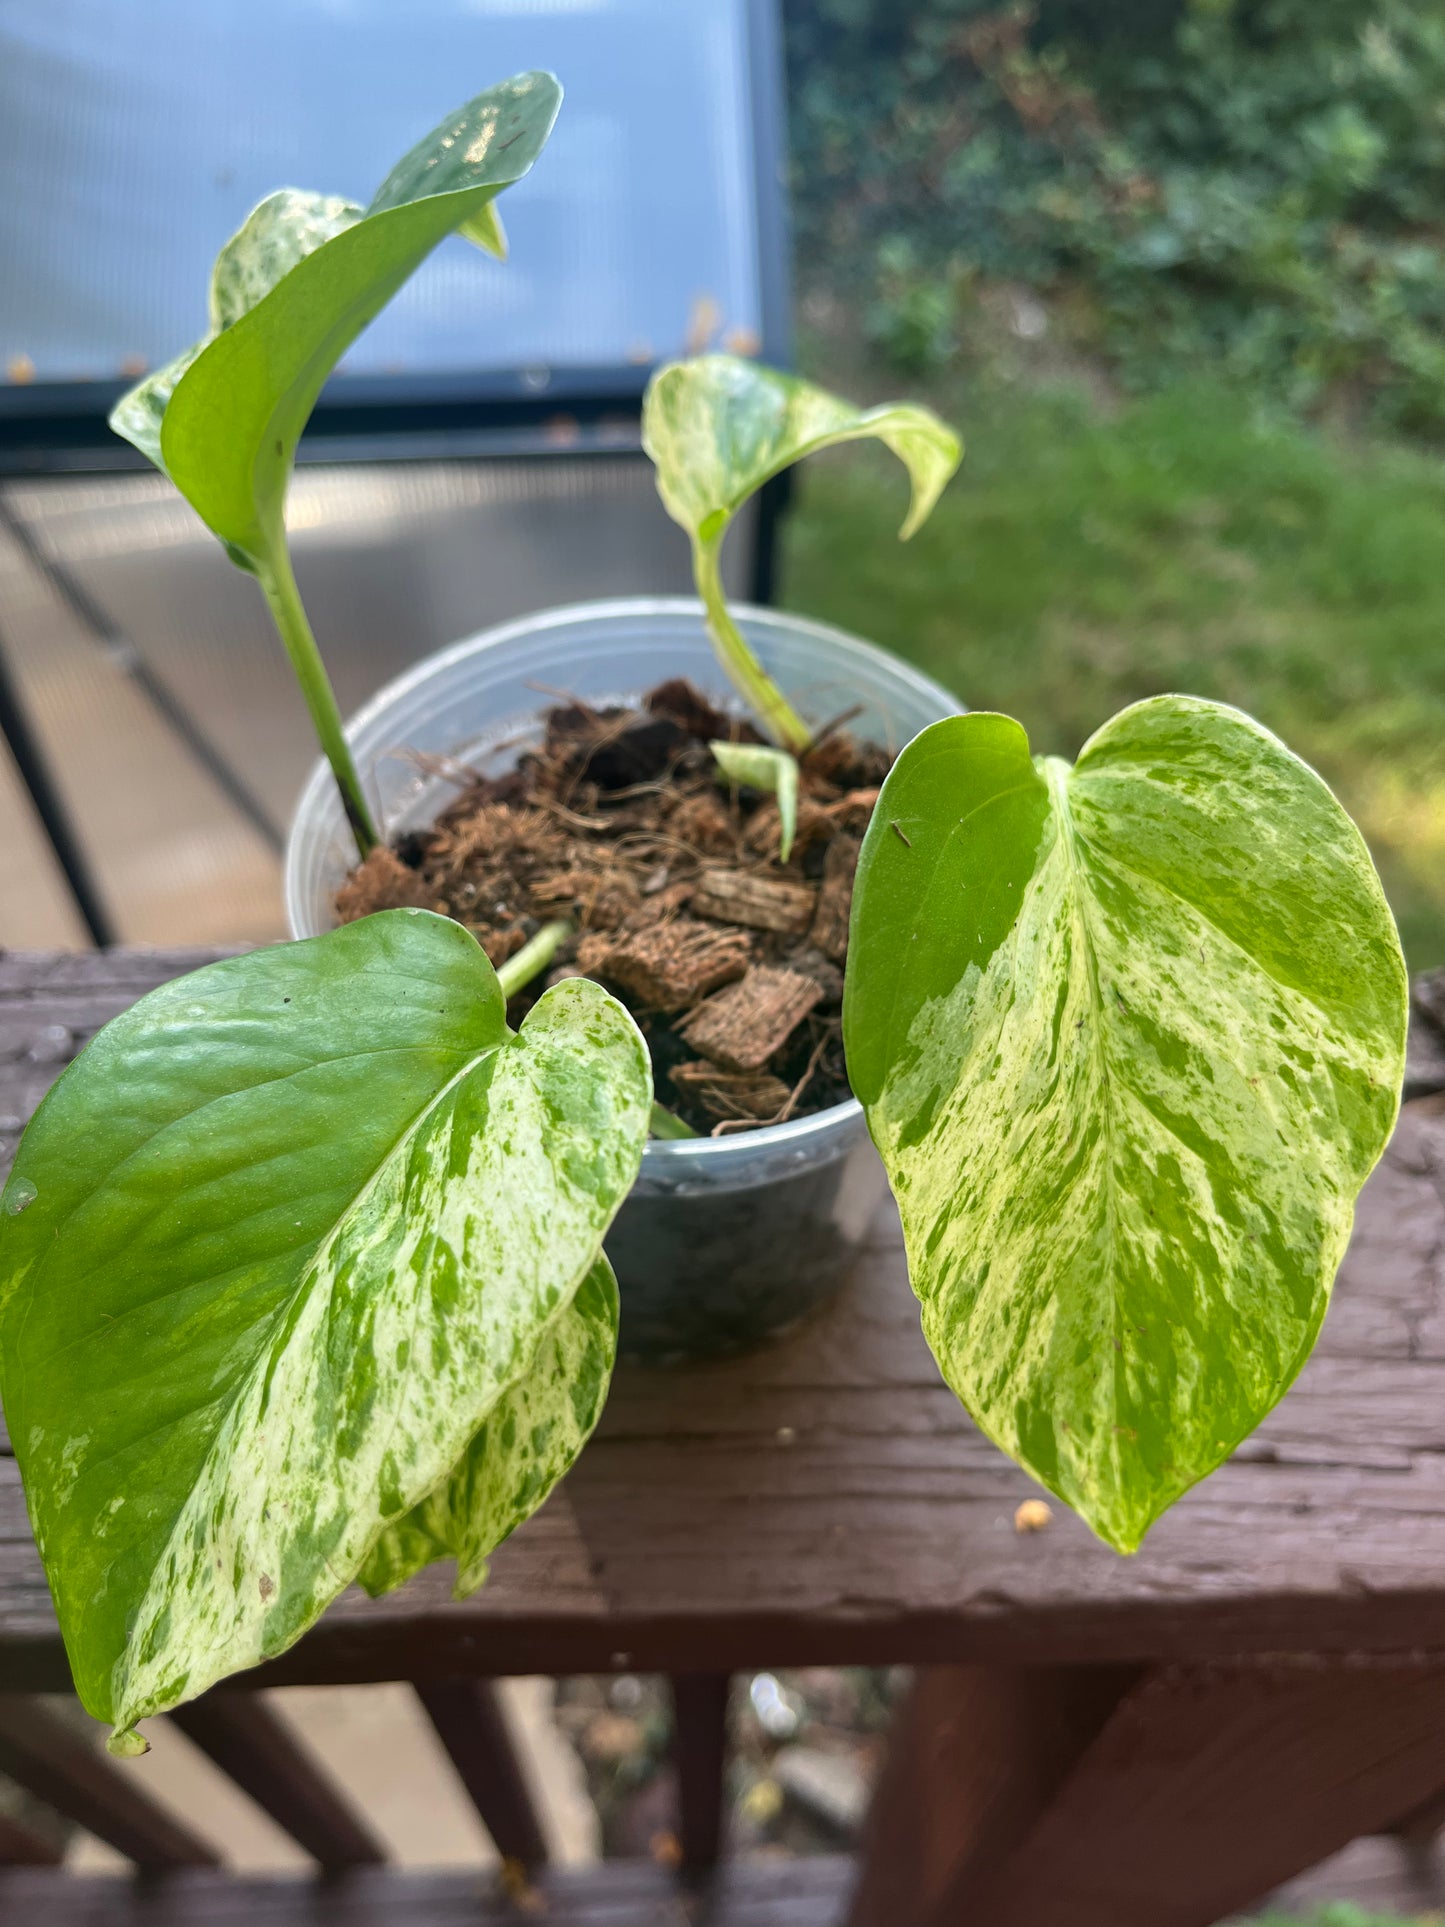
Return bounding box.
[909,1659,1445,1927]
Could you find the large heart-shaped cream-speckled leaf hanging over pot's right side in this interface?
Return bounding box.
[844,696,1406,1551]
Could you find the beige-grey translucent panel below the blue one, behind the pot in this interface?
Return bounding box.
[0,466,751,944]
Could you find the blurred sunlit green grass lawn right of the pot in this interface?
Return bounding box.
[780,375,1445,969]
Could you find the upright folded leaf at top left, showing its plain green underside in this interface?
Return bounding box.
[112,73,561,565]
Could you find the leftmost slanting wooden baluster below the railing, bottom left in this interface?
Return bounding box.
[0,1694,218,1871]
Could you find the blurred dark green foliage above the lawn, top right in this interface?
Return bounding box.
[786,0,1445,436]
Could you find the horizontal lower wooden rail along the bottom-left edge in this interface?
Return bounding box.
[0,1856,852,1927]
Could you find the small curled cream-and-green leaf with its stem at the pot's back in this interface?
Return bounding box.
[642,355,963,750]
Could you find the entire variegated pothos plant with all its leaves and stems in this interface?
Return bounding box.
[0,75,1405,1752]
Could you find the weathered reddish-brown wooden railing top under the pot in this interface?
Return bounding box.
[0,952,1445,1688]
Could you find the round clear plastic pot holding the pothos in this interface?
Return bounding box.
[285,597,959,1362]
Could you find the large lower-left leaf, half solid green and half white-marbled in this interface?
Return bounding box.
[0,911,651,1734]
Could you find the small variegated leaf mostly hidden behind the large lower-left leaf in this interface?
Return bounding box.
[356,1256,618,1599]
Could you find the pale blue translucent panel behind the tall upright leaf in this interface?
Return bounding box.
[0,0,778,382]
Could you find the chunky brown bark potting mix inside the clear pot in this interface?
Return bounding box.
[337,682,890,1135]
